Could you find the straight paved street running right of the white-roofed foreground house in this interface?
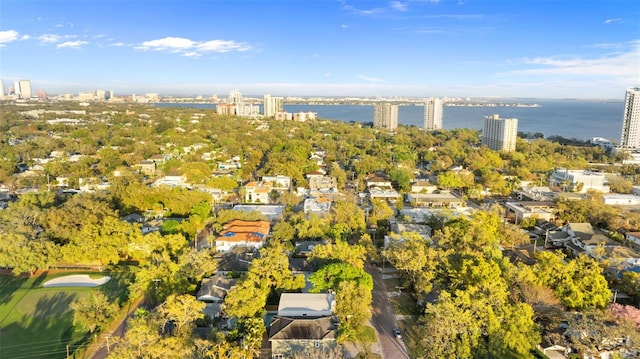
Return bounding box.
[365,263,409,359]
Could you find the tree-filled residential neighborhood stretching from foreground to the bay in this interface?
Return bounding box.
[0,100,640,359]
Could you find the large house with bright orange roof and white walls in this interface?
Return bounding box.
[215,219,271,252]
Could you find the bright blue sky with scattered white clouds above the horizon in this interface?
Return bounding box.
[0,0,640,99]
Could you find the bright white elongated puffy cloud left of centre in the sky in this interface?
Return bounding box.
[136,37,251,57]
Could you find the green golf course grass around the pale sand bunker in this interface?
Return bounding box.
[0,272,132,359]
